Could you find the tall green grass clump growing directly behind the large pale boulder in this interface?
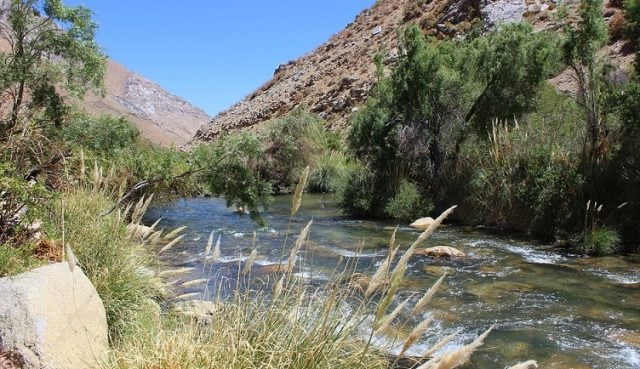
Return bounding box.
[54,189,163,342]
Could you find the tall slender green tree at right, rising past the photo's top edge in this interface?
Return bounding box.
[564,0,608,161]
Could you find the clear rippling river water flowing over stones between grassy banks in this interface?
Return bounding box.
[146,195,640,369]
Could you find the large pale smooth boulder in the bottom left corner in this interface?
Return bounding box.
[0,263,108,369]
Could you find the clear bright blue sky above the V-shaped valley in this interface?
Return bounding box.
[65,0,375,115]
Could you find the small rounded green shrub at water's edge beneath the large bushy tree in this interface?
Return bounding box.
[384,181,433,220]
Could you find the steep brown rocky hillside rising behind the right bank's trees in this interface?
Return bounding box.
[196,0,632,141]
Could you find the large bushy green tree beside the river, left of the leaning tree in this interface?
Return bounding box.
[345,25,465,216]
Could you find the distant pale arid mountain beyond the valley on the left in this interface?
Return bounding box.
[0,0,211,146]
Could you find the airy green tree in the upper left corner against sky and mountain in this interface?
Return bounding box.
[0,0,106,136]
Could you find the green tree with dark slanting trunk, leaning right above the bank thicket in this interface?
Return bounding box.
[454,23,559,167]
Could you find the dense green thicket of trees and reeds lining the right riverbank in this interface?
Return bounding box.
[342,1,640,254]
